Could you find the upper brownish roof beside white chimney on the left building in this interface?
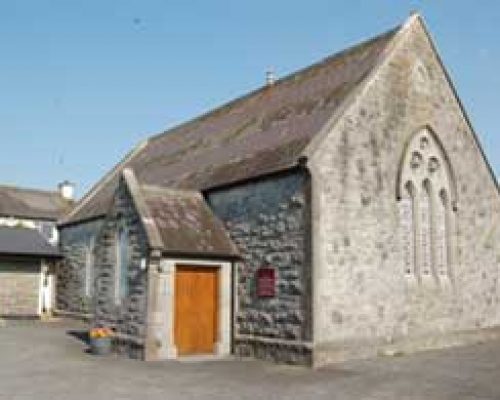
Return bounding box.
[0,186,72,221]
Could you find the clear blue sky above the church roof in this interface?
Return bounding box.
[0,0,500,195]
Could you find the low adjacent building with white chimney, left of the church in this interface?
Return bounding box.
[0,182,72,318]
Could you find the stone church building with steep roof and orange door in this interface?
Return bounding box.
[57,15,500,366]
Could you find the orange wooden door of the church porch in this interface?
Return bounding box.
[174,266,219,355]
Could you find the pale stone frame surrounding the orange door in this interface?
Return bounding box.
[153,258,233,359]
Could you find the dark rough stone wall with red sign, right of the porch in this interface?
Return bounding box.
[207,172,311,363]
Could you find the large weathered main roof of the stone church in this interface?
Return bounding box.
[61,27,399,224]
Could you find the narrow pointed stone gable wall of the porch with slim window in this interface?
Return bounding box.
[94,177,148,358]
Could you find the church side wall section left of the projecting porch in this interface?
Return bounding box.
[56,219,102,313]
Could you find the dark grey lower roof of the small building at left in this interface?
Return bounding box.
[0,227,60,258]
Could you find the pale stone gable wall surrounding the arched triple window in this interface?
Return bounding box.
[308,19,500,364]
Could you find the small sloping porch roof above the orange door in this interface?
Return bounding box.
[122,168,238,257]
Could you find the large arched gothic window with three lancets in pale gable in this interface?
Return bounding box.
[396,128,456,282]
